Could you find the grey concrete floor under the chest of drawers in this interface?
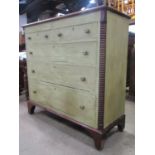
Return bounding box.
[19,96,135,155]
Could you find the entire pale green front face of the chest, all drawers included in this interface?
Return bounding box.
[25,11,100,128]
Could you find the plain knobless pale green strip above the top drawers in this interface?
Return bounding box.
[25,12,99,33]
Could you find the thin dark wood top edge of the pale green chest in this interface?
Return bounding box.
[23,5,130,28]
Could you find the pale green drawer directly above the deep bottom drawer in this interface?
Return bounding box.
[28,61,97,91]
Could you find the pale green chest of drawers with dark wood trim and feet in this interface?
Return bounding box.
[24,6,129,149]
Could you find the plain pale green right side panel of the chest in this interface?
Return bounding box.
[104,11,129,127]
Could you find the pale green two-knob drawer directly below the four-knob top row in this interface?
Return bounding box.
[28,42,99,66]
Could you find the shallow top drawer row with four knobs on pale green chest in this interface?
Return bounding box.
[26,23,99,44]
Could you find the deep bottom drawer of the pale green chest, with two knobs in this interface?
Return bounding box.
[29,80,97,128]
